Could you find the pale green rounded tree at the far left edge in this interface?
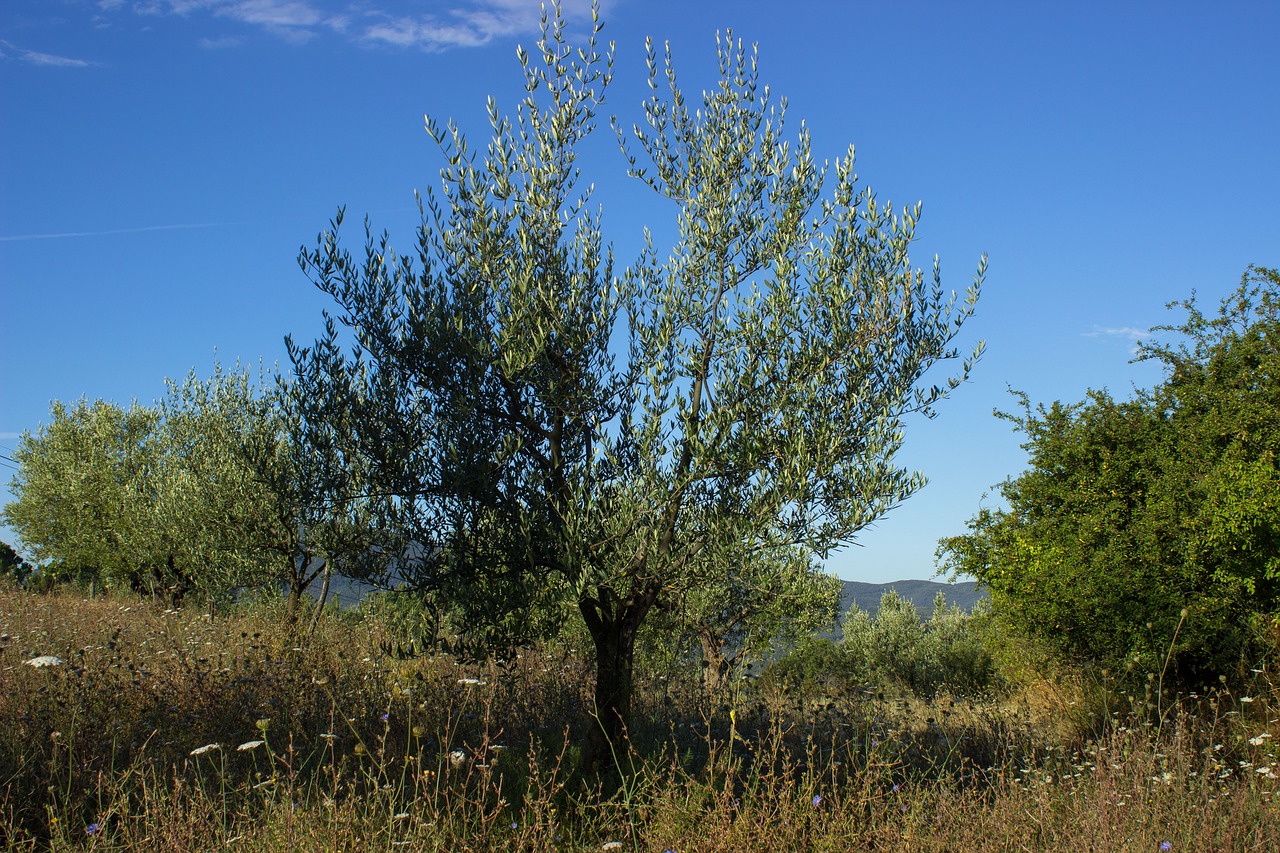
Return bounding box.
[4,400,163,589]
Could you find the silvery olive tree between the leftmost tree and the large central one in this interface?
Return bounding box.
[148,365,387,620]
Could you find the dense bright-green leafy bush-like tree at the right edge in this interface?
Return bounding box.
[938,268,1280,684]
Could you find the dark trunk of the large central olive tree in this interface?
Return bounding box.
[579,601,649,775]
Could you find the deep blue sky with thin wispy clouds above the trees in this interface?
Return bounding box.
[0,0,1280,581]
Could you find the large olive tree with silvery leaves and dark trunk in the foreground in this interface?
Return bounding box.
[291,4,982,766]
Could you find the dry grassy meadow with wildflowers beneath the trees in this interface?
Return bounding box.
[0,587,1280,853]
